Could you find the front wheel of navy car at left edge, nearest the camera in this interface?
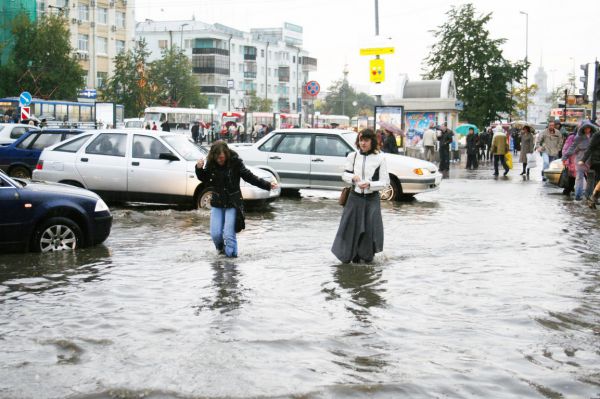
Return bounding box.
[32,217,83,252]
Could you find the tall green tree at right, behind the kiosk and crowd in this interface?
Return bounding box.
[424,4,525,126]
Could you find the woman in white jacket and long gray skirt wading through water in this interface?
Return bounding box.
[331,129,390,263]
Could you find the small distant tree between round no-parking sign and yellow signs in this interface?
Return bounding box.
[319,79,375,117]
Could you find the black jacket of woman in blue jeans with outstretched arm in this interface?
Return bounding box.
[196,151,271,208]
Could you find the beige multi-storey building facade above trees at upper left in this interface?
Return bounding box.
[37,0,135,90]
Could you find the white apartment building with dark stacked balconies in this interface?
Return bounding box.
[136,20,317,113]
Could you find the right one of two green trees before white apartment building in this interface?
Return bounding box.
[150,46,208,108]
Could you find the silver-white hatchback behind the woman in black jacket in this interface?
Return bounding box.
[33,129,281,208]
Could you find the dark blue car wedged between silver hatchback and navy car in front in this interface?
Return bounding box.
[0,129,83,179]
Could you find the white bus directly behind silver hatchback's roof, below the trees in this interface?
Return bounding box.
[144,107,220,133]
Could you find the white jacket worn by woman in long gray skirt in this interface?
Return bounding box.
[342,151,390,194]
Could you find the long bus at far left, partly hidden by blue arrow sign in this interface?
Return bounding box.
[0,97,125,128]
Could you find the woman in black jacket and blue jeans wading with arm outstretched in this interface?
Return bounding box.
[196,141,277,258]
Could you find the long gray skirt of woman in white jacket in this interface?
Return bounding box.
[331,192,383,263]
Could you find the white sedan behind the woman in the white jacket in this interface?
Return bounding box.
[235,129,442,201]
